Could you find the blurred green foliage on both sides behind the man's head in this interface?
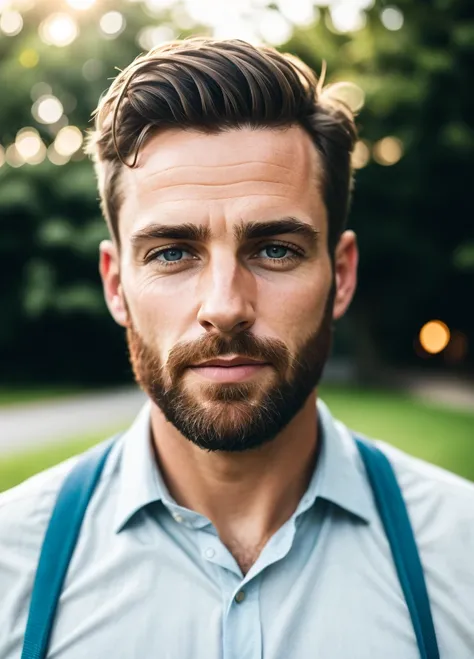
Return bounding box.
[0,0,474,381]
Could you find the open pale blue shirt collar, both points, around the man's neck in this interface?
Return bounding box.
[114,400,373,533]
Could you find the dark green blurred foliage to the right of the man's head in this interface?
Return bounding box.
[291,0,474,379]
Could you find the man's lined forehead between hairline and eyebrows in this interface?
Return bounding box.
[119,126,326,242]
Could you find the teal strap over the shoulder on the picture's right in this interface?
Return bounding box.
[355,437,439,659]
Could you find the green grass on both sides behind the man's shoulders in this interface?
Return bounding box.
[0,386,474,491]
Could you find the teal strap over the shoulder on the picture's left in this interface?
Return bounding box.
[21,437,116,659]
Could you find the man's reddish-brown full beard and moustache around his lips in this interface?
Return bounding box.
[127,286,335,452]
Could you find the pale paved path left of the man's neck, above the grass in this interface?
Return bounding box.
[0,387,145,455]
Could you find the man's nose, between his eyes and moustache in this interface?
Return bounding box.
[198,255,255,334]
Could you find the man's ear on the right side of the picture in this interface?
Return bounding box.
[333,231,359,320]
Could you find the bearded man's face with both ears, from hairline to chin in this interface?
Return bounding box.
[101,127,357,451]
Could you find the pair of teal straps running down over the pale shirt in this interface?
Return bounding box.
[21,437,439,659]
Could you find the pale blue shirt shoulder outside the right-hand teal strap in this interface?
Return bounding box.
[375,441,474,657]
